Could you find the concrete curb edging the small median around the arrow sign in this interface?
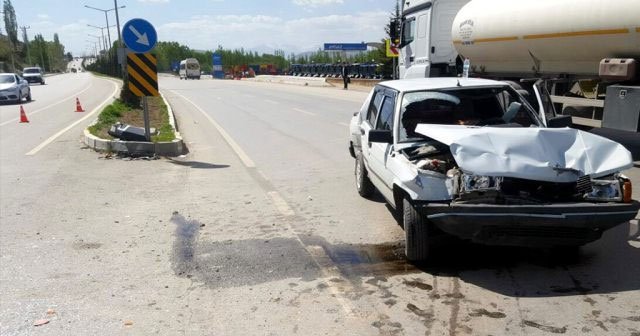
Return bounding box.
[84,94,185,156]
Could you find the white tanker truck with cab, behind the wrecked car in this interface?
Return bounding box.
[399,0,640,136]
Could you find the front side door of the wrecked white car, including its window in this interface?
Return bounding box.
[363,89,396,201]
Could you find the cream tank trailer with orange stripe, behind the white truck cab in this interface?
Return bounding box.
[451,0,640,149]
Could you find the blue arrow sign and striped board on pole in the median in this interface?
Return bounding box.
[122,19,160,141]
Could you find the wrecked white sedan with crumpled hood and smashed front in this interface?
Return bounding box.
[350,78,640,260]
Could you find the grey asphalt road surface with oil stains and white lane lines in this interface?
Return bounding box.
[0,73,640,336]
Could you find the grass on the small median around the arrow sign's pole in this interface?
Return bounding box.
[89,97,176,142]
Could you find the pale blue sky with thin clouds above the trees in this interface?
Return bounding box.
[7,0,396,56]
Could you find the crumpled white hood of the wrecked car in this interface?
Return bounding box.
[416,124,633,182]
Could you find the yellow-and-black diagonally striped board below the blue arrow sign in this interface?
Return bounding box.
[127,53,160,97]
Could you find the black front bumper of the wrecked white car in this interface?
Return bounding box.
[416,201,640,247]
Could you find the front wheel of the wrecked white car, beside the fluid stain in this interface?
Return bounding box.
[402,197,430,261]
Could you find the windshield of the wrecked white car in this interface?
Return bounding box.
[399,86,540,142]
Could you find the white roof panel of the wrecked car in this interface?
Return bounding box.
[378,77,509,92]
